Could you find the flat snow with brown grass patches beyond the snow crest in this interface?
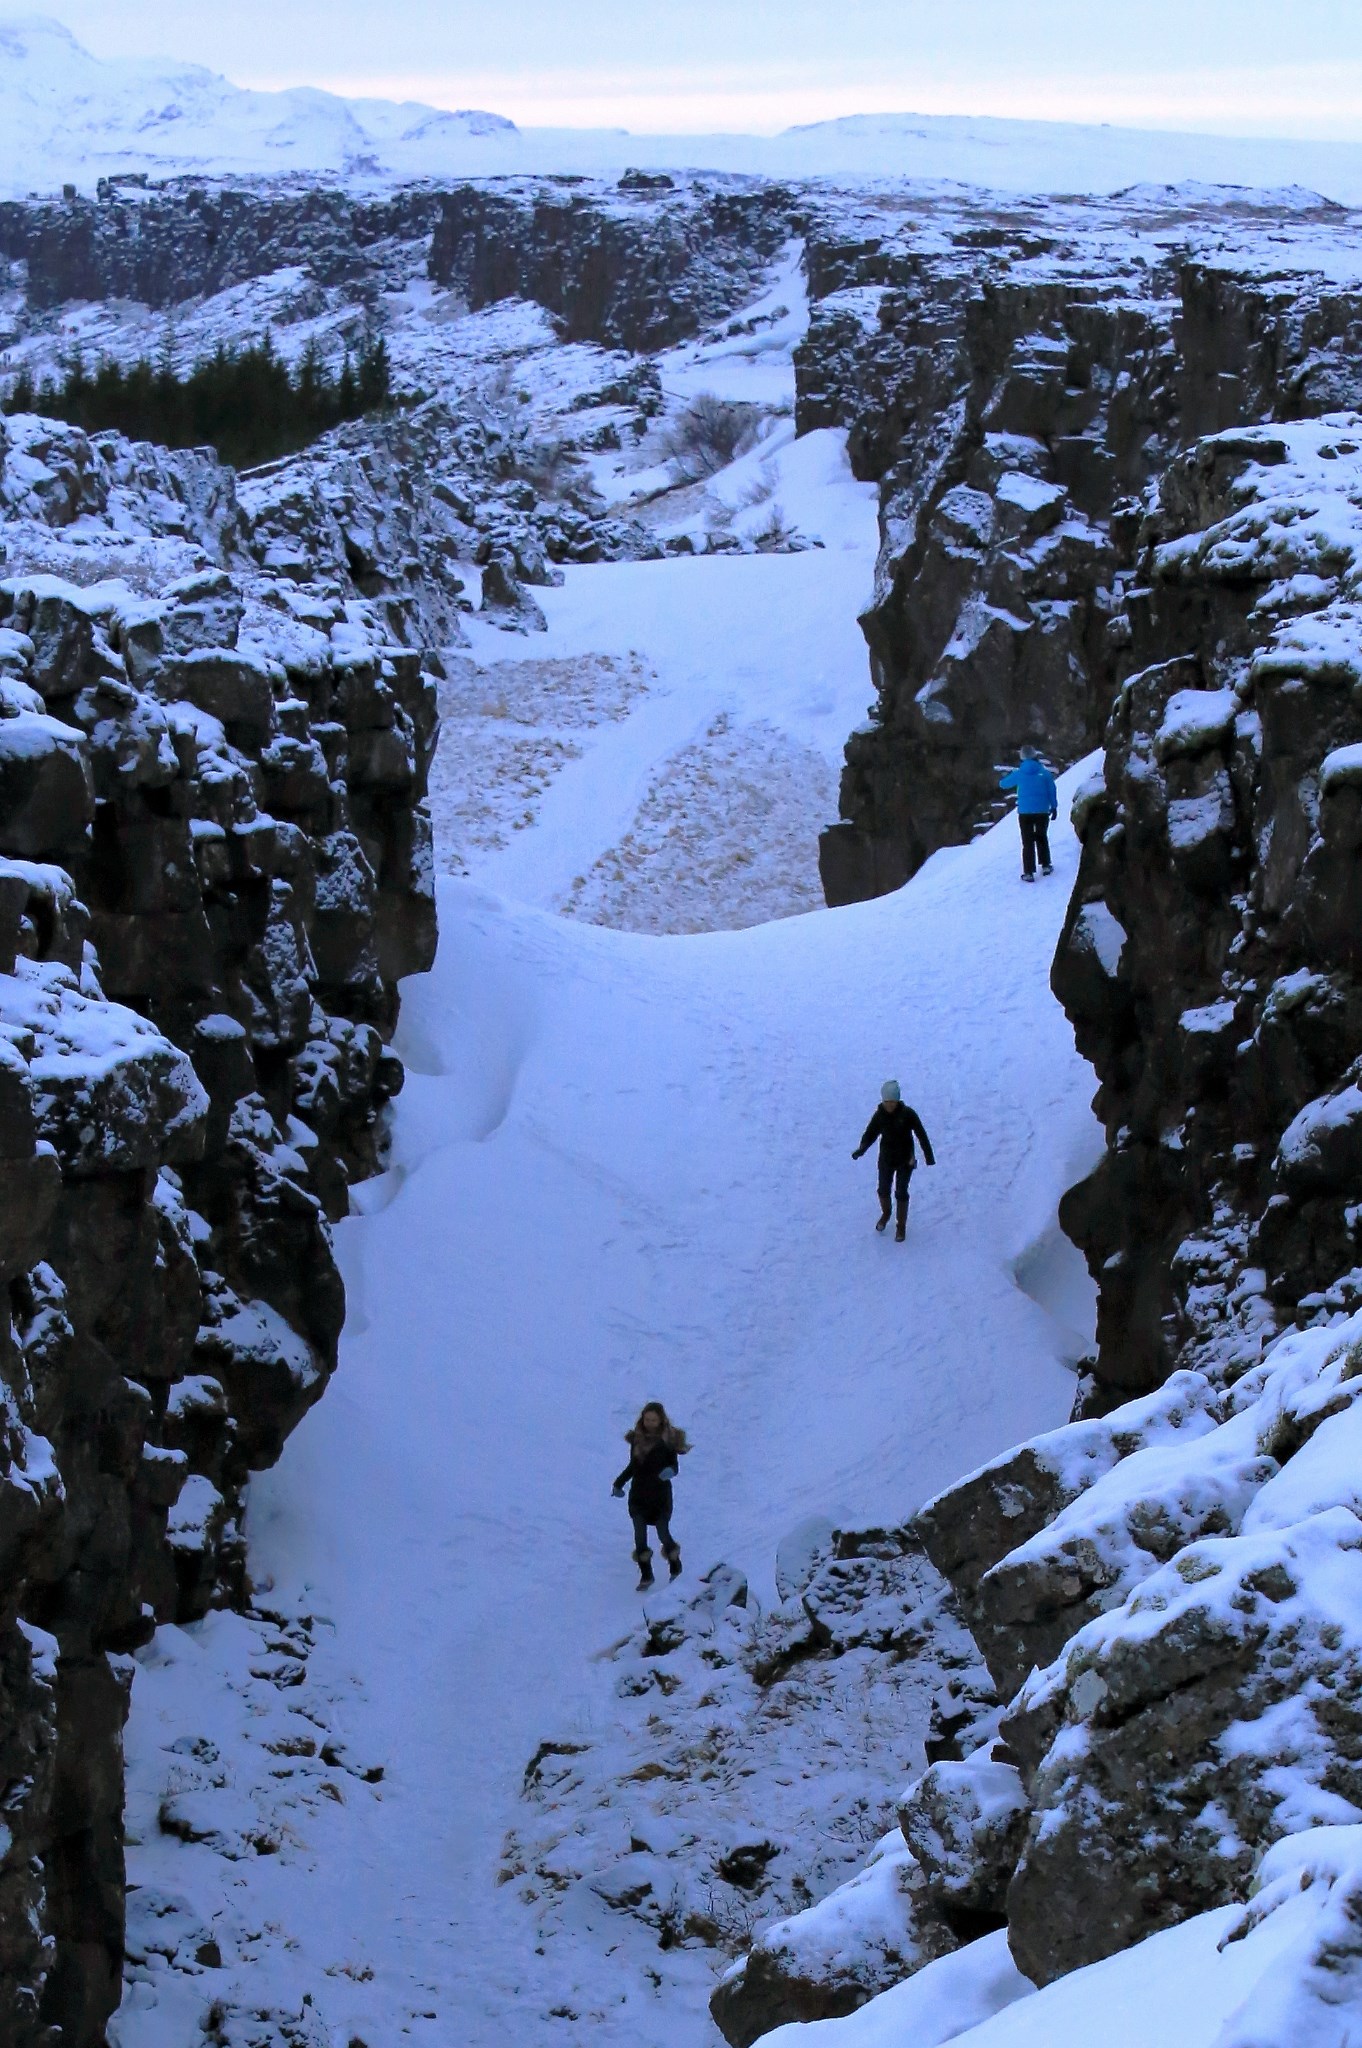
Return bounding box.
[432,415,879,930]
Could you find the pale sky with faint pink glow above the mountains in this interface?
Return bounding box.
[47,0,1362,141]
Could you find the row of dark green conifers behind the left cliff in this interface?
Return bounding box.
[0,334,391,469]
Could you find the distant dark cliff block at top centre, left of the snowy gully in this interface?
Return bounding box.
[430,178,795,352]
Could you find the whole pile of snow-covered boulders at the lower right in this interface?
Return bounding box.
[715,1315,1362,2044]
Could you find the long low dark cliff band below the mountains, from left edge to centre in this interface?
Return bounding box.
[0,176,797,352]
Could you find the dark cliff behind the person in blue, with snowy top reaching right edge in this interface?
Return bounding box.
[797,203,1362,903]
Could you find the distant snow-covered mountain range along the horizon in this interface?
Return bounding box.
[0,14,1362,207]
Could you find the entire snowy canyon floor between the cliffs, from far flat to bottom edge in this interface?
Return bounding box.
[117,407,1098,2048]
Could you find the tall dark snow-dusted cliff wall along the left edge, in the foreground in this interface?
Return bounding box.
[0,407,434,2048]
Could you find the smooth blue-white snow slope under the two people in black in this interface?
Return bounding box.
[231,757,1094,2048]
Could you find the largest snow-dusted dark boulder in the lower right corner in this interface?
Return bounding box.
[1006,1507,1362,1982]
